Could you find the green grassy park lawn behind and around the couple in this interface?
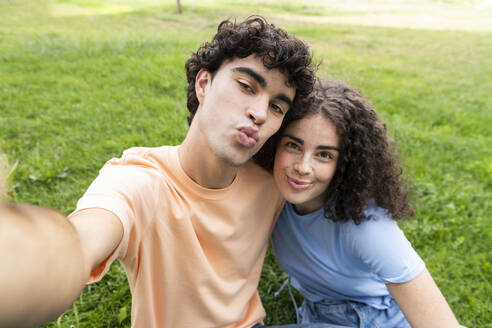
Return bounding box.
[0,0,492,327]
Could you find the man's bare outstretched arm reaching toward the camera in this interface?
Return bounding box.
[0,203,123,328]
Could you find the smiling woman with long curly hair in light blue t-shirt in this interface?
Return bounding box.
[266,81,459,328]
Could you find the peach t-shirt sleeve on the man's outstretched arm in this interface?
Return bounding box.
[71,152,157,284]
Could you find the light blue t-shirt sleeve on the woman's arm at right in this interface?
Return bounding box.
[347,208,425,284]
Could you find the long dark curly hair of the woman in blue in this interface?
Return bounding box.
[255,80,414,224]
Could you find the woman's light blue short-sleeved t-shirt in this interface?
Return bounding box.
[273,202,425,310]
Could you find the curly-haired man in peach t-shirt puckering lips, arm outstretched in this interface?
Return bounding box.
[0,17,314,327]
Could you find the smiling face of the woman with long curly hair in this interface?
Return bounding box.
[273,113,339,214]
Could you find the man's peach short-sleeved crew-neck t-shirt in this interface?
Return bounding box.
[71,146,283,328]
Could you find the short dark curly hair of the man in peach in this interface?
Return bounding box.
[185,16,315,124]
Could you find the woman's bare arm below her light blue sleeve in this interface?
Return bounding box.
[386,269,460,328]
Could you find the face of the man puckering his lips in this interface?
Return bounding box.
[194,56,295,166]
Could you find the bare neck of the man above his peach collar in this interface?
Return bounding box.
[178,134,238,189]
